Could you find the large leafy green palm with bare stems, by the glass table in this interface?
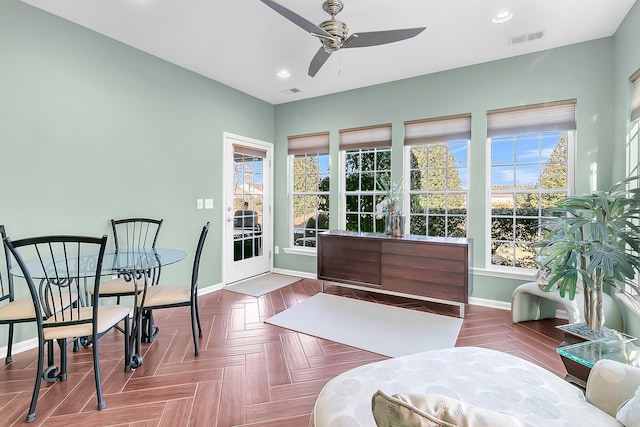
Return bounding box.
[537,176,640,337]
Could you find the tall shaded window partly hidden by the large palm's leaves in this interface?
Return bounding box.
[487,100,575,268]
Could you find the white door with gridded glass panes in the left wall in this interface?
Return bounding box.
[222,133,273,285]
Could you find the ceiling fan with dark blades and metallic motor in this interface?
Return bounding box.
[261,0,425,77]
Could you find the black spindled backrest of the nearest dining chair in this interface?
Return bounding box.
[5,235,107,331]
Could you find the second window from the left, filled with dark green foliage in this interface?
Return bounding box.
[340,125,391,233]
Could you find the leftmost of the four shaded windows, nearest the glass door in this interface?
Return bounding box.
[289,132,329,248]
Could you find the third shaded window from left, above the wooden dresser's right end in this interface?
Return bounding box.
[404,114,471,237]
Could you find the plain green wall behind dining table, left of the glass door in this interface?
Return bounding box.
[0,0,275,346]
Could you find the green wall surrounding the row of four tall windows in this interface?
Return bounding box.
[274,5,640,308]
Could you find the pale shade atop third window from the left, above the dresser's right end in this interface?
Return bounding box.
[404,114,471,145]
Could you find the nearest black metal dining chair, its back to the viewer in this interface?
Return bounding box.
[5,236,131,422]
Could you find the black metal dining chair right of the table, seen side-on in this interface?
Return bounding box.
[143,222,210,356]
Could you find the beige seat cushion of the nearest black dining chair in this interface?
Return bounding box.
[44,305,131,340]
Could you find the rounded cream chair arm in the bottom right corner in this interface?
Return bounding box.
[586,359,640,417]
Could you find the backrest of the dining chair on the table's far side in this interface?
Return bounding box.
[111,218,163,250]
